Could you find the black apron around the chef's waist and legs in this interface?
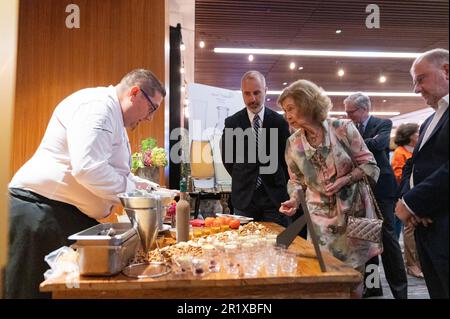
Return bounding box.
[4,188,98,298]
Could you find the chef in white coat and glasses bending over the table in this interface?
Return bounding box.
[4,69,166,298]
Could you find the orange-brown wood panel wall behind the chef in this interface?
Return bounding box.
[11,0,168,184]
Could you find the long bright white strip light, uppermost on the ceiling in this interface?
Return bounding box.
[214,48,421,59]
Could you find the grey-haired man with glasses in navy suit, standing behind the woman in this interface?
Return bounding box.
[344,92,408,299]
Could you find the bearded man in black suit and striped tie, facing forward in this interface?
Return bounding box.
[222,71,290,227]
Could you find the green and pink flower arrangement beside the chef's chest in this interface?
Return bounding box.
[131,137,168,173]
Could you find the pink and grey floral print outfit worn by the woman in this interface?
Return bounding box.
[285,119,380,268]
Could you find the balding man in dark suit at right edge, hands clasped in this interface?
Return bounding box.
[395,49,449,299]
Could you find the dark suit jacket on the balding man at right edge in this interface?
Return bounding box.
[400,109,449,219]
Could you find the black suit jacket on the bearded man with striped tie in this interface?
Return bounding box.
[221,107,290,210]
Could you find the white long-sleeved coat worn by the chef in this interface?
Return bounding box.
[9,86,142,219]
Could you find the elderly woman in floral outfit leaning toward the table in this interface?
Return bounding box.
[278,80,381,272]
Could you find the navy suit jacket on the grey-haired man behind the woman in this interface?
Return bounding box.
[363,116,397,199]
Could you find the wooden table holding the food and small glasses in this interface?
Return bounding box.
[40,223,362,299]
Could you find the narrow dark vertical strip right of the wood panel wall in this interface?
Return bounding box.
[169,24,182,189]
